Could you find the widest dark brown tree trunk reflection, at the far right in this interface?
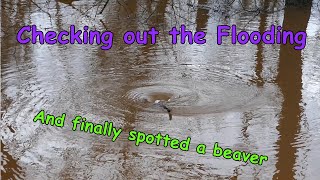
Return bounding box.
[274,3,311,179]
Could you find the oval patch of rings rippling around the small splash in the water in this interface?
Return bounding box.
[126,83,259,115]
